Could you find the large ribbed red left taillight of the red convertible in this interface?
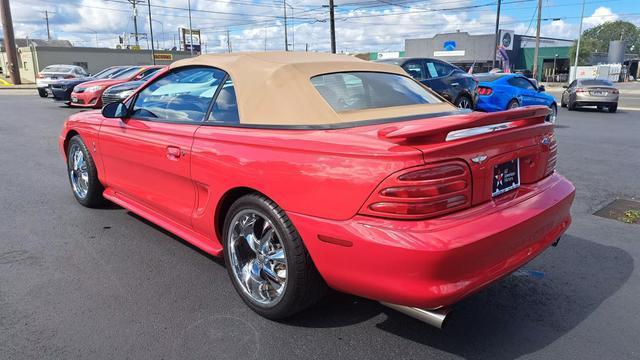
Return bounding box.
[360,161,471,219]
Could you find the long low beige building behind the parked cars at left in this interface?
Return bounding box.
[0,39,190,83]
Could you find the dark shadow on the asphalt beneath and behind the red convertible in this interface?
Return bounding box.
[287,235,634,359]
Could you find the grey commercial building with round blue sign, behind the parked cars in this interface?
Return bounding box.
[405,30,573,81]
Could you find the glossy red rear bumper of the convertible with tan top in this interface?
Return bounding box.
[289,174,575,309]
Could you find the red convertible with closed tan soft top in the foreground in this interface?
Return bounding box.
[59,53,575,326]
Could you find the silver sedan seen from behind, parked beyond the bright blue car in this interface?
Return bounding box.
[560,79,619,112]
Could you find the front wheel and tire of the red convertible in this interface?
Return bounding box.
[67,135,104,208]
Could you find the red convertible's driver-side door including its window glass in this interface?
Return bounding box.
[99,67,225,226]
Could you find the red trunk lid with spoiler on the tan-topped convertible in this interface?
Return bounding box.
[378,106,556,205]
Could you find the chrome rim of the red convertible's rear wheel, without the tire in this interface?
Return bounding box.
[227,209,287,306]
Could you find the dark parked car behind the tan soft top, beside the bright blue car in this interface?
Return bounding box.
[379,58,478,109]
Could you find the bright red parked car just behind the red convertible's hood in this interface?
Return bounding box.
[68,65,164,109]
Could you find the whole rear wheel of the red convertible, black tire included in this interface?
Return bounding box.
[223,194,327,320]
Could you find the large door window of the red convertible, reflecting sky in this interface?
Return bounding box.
[131,67,226,122]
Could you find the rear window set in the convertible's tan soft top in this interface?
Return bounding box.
[311,72,442,112]
